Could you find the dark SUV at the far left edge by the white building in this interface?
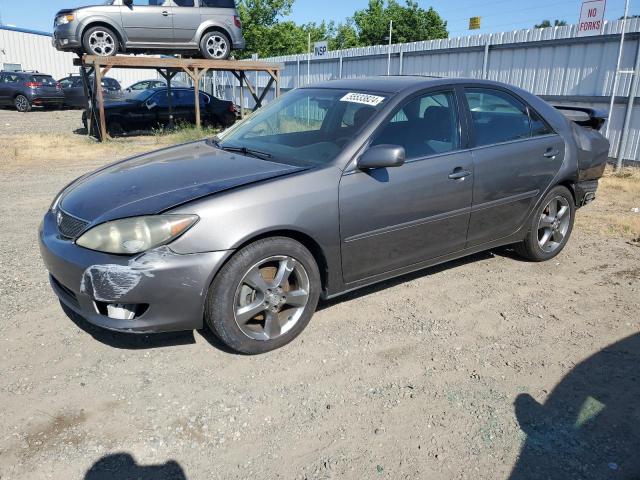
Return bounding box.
[0,72,64,112]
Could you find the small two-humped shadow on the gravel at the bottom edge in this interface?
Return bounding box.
[84,453,187,480]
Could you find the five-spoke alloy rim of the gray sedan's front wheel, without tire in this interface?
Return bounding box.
[233,255,309,340]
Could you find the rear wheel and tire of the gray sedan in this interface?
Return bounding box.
[516,185,576,262]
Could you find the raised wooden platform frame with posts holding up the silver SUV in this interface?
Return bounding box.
[74,55,282,141]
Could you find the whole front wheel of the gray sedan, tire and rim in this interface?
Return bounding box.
[205,237,322,354]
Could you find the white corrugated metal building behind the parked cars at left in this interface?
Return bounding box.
[0,26,152,88]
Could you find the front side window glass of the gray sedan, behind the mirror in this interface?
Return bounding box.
[372,92,460,160]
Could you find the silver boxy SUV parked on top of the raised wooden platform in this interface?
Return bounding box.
[52,0,245,60]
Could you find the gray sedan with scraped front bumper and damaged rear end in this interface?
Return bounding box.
[40,77,609,353]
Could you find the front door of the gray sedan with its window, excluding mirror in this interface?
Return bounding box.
[340,90,473,284]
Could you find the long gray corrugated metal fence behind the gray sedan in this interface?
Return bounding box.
[217,18,640,160]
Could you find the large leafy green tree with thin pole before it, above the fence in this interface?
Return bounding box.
[353,0,449,45]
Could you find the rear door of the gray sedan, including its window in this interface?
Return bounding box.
[464,87,564,247]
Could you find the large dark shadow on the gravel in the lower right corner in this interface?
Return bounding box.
[510,333,640,480]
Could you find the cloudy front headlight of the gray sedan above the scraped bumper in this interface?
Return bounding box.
[76,214,198,255]
